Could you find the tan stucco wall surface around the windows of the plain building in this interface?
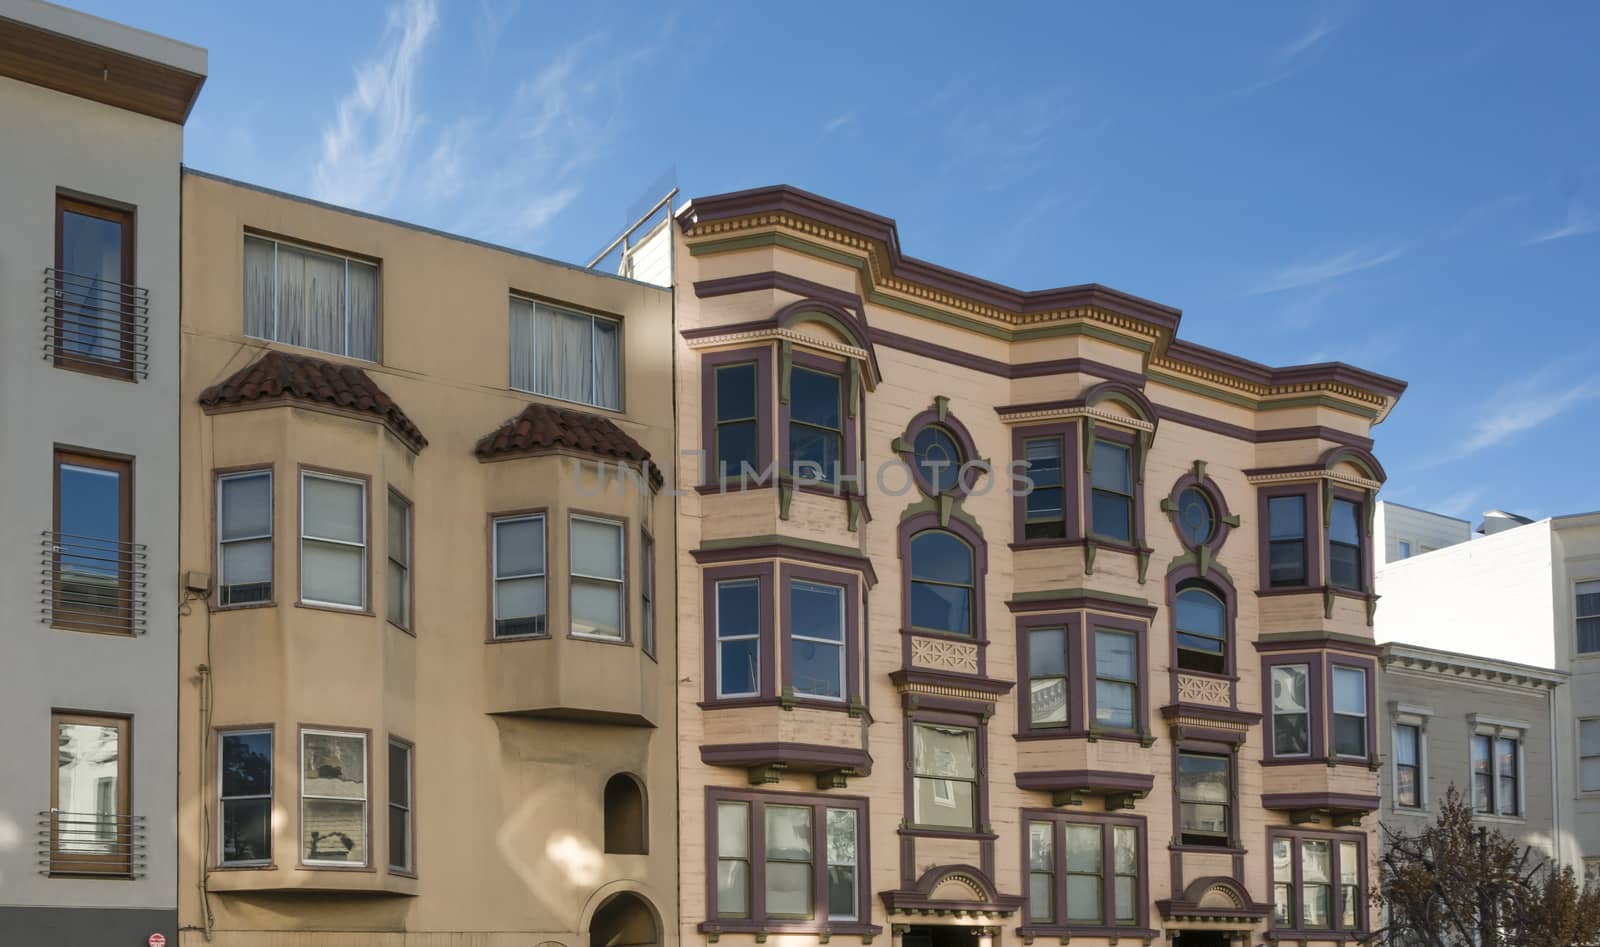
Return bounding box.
[179,174,677,947]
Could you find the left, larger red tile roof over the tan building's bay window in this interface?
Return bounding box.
[200,349,427,451]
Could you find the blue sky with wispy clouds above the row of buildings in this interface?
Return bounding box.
[72,0,1600,517]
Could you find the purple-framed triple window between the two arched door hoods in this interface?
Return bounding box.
[1027,816,1144,929]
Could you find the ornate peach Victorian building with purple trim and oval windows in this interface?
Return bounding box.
[675,187,1403,947]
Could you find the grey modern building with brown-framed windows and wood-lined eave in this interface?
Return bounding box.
[0,0,206,947]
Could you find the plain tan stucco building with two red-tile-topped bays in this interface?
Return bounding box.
[178,173,677,947]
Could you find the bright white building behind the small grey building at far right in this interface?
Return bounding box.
[1374,512,1600,878]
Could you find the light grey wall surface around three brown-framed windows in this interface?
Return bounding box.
[0,71,184,908]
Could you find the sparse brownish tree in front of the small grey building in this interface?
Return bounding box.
[1373,785,1600,947]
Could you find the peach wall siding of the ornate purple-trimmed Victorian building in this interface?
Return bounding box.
[677,213,1378,945]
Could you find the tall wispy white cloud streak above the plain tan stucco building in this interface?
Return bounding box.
[312,0,438,211]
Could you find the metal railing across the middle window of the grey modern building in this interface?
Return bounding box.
[40,531,149,633]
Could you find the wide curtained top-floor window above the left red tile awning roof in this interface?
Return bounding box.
[245,235,378,362]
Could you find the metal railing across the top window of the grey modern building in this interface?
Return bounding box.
[45,267,150,378]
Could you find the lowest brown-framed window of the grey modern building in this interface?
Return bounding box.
[50,713,131,875]
